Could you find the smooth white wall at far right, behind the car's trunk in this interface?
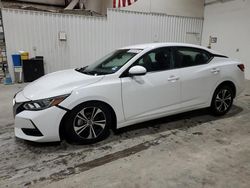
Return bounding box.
[202,0,250,79]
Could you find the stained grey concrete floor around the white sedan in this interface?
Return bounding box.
[0,81,250,188]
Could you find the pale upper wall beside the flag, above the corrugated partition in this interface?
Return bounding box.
[101,0,204,18]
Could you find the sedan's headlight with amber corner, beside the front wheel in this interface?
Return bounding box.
[23,95,69,111]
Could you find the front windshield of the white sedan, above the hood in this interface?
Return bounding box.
[76,49,142,75]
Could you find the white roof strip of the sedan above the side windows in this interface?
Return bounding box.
[121,42,223,55]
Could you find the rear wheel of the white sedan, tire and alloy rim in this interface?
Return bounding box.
[210,85,234,116]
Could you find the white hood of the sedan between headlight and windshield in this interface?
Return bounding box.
[23,69,104,100]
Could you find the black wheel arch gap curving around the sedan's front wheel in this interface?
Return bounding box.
[59,100,117,140]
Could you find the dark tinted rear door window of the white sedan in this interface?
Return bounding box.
[174,47,210,68]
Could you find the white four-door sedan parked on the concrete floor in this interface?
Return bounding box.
[13,43,245,144]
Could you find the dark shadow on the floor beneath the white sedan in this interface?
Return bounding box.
[16,105,243,149]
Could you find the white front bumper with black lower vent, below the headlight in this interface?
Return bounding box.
[15,106,66,142]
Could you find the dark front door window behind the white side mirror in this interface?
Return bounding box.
[134,48,172,72]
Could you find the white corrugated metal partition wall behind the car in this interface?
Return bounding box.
[2,9,203,81]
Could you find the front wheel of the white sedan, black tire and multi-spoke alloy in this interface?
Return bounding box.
[64,102,112,144]
